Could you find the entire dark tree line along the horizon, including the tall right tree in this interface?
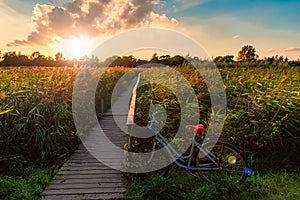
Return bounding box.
[0,45,300,68]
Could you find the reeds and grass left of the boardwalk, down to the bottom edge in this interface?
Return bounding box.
[0,67,129,199]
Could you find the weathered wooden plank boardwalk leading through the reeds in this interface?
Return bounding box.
[42,75,136,200]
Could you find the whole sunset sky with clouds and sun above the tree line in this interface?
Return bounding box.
[0,0,300,60]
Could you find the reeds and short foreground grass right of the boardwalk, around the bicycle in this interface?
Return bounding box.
[127,66,300,200]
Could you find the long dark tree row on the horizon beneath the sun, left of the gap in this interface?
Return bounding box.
[0,51,187,67]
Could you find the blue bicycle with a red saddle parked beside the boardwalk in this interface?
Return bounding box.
[148,112,254,184]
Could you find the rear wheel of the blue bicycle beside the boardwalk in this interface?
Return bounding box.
[195,142,247,184]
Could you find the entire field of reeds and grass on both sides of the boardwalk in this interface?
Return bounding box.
[0,66,300,199]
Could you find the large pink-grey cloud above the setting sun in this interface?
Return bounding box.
[7,0,178,46]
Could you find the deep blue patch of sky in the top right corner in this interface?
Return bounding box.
[178,0,300,30]
